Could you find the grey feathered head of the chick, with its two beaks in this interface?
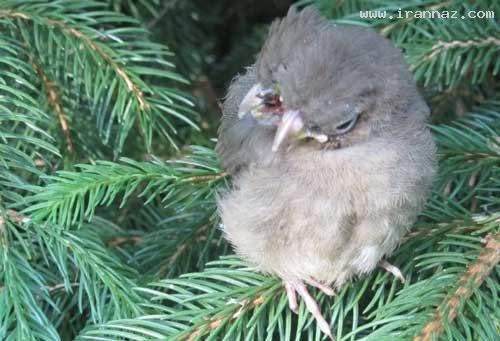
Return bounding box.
[238,8,428,151]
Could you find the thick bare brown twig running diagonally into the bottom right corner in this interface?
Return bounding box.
[413,233,500,341]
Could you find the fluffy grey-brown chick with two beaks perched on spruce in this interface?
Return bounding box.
[215,6,437,339]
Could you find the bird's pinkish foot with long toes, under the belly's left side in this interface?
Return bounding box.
[285,280,335,340]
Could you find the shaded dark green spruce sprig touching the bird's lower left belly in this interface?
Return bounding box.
[128,199,229,278]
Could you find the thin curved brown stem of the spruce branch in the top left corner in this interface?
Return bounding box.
[0,10,149,111]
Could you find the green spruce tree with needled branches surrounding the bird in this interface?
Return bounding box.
[0,0,500,340]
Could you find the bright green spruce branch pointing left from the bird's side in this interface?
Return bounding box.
[24,146,227,226]
